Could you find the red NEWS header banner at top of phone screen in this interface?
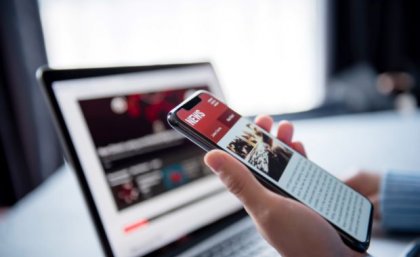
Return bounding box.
[177,94,241,143]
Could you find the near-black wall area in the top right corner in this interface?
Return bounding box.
[329,0,420,75]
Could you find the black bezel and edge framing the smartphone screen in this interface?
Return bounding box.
[168,90,374,252]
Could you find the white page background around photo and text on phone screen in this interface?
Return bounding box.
[218,117,370,242]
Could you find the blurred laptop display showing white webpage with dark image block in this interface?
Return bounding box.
[52,65,240,256]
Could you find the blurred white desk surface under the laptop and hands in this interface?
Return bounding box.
[0,112,420,257]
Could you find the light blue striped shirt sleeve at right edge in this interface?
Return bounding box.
[379,171,420,232]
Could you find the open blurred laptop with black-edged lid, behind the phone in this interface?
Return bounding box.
[37,63,278,257]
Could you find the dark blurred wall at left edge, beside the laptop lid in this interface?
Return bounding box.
[0,0,62,205]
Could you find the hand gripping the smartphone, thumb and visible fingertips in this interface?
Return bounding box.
[205,116,364,257]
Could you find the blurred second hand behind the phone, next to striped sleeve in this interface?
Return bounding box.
[346,170,381,220]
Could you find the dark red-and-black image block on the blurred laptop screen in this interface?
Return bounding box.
[79,86,211,210]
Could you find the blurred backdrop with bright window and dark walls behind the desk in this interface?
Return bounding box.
[0,0,420,207]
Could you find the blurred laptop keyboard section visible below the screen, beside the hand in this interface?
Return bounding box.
[197,224,280,257]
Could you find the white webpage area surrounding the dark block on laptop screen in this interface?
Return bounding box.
[53,67,240,256]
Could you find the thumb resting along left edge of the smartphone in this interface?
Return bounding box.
[204,150,271,214]
